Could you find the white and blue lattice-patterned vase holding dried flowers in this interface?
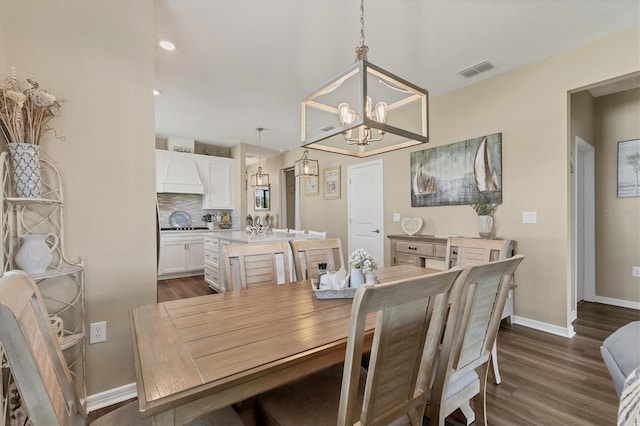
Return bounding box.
[9,143,42,198]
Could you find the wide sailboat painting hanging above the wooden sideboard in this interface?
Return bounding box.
[411,133,502,207]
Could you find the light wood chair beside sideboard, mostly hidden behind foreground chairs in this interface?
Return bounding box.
[445,237,516,385]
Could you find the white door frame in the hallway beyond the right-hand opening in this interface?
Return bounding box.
[570,136,596,321]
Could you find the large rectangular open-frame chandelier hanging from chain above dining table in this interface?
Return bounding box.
[300,0,429,157]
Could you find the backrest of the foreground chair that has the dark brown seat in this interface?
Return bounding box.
[356,270,458,424]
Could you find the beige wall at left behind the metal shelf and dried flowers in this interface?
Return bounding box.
[0,0,156,394]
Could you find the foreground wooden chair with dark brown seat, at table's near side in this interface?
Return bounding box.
[258,268,461,426]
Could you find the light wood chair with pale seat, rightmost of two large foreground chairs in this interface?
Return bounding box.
[428,255,524,426]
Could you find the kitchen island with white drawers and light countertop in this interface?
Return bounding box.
[204,230,318,293]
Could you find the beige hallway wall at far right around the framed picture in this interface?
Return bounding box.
[594,89,640,302]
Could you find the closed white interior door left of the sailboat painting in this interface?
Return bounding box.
[347,160,384,266]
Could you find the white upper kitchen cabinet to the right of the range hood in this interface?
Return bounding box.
[196,155,233,209]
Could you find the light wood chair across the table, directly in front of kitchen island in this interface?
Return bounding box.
[222,241,291,290]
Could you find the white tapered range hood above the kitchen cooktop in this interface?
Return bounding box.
[156,150,204,194]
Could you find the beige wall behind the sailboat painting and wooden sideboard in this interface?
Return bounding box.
[290,26,640,332]
